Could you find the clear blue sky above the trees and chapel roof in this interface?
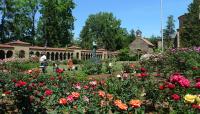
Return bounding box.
[73,0,192,38]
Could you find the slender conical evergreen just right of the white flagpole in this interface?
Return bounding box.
[163,15,175,48]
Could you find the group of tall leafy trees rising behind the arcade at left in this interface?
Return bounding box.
[0,0,75,47]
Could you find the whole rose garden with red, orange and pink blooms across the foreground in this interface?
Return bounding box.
[0,48,200,114]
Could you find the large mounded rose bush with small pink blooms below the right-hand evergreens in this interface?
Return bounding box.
[141,48,200,77]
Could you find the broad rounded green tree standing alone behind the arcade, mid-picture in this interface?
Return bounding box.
[80,12,128,50]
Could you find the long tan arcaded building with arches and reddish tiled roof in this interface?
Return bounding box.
[0,40,118,61]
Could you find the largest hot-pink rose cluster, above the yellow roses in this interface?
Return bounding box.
[170,73,190,88]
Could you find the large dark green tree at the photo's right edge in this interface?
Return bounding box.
[180,0,200,47]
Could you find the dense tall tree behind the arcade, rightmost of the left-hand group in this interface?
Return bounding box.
[38,0,75,47]
